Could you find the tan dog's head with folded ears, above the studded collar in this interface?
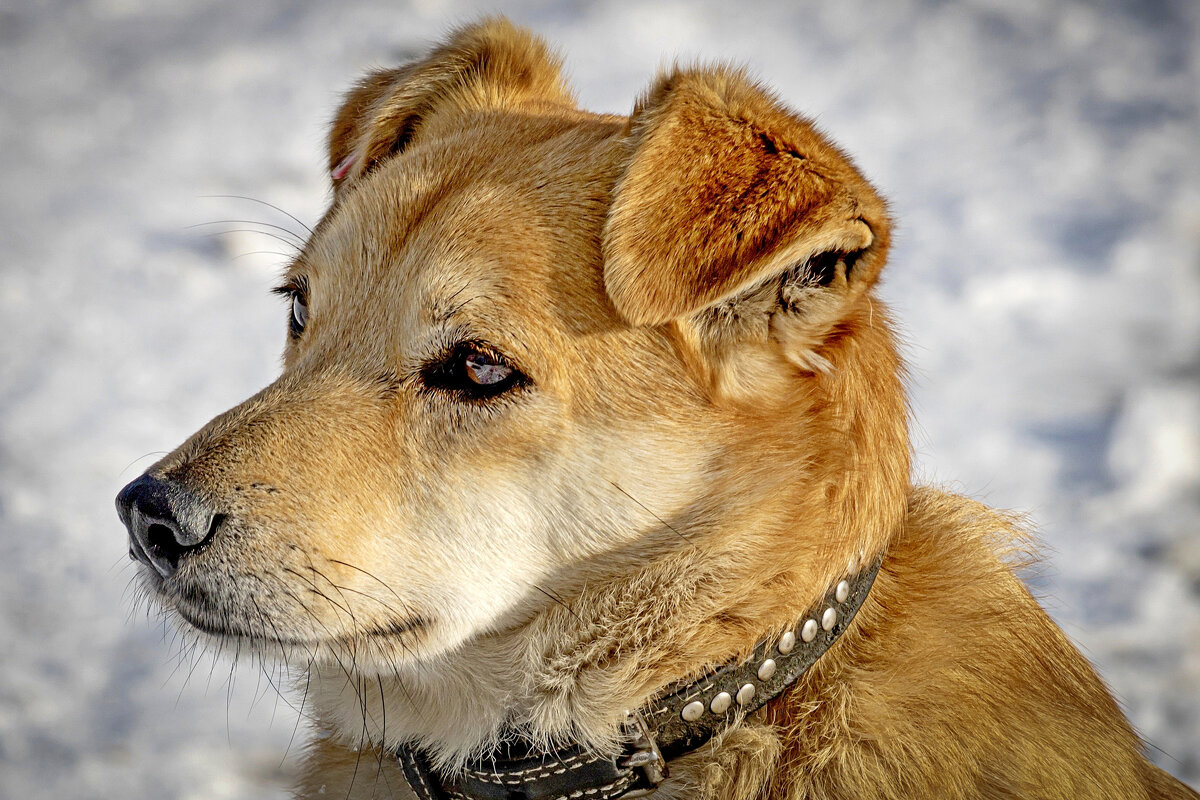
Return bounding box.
[118,22,907,743]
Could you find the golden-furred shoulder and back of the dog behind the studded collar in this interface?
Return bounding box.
[776,488,1152,798]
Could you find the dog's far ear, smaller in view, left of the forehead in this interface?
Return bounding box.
[329,18,575,192]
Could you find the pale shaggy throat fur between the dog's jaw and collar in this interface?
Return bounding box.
[310,513,892,772]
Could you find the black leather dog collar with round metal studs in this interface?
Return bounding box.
[396,557,883,800]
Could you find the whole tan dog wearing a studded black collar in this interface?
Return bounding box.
[118,18,1200,800]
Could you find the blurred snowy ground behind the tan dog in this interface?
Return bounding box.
[0,0,1200,799]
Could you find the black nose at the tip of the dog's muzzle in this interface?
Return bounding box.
[116,475,221,578]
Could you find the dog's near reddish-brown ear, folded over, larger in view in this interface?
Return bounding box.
[602,67,888,374]
